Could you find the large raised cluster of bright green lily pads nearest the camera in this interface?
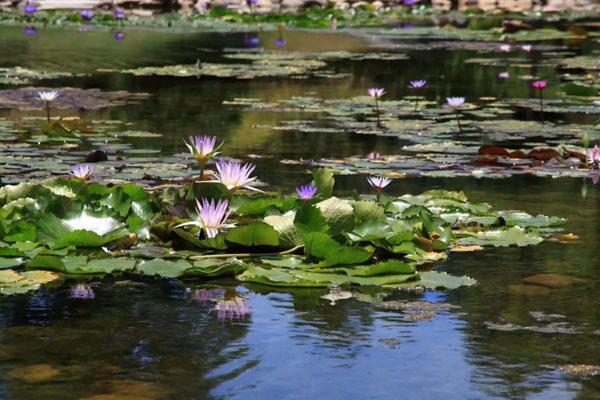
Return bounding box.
[0,166,565,294]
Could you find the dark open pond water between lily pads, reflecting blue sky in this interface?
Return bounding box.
[0,28,600,400]
